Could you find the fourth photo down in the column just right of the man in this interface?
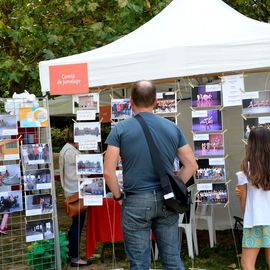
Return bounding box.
[195,158,226,181]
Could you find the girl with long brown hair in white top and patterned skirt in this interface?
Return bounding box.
[236,127,270,270]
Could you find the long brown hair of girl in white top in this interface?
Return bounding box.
[241,127,270,190]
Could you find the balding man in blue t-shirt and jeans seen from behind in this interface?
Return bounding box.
[104,81,197,270]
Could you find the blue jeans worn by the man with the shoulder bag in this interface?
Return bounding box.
[122,191,185,270]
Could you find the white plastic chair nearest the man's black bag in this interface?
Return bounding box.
[178,184,199,258]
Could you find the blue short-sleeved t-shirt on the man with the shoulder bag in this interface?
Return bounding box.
[105,112,187,193]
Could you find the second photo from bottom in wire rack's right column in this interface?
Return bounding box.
[25,194,53,216]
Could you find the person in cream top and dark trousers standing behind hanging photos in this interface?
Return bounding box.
[59,127,90,267]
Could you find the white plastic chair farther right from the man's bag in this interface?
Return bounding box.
[194,205,217,248]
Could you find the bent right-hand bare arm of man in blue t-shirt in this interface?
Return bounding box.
[176,144,198,183]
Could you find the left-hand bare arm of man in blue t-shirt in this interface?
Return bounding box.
[104,145,121,198]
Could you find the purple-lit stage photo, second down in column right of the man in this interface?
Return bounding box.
[192,110,222,132]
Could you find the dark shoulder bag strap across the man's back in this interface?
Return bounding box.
[135,114,173,196]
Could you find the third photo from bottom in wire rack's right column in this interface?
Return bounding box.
[23,169,52,191]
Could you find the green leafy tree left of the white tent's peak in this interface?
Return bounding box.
[0,0,170,97]
